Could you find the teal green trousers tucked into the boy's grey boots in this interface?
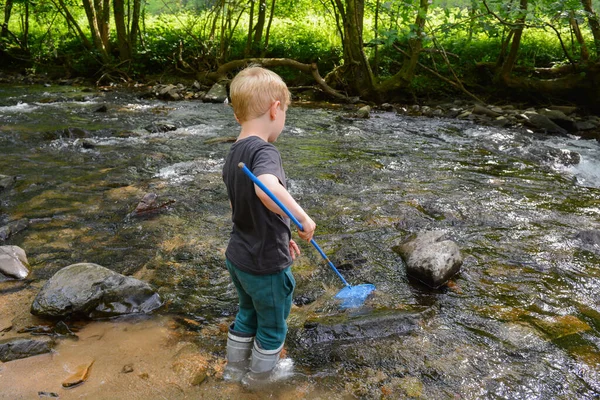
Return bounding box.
[225,260,296,350]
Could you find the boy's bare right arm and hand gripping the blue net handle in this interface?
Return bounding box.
[254,174,317,242]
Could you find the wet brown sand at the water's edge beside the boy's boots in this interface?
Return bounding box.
[0,282,344,400]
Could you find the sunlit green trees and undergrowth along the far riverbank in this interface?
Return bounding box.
[0,0,600,101]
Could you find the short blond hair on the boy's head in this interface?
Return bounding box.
[229,66,290,123]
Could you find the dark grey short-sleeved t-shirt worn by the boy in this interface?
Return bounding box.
[223,136,292,275]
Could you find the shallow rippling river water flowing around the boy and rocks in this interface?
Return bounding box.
[0,86,600,399]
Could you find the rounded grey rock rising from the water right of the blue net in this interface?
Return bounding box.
[393,231,463,289]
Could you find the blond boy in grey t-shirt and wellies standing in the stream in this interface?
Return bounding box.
[223,67,316,383]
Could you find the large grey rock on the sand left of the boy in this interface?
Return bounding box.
[31,263,161,319]
